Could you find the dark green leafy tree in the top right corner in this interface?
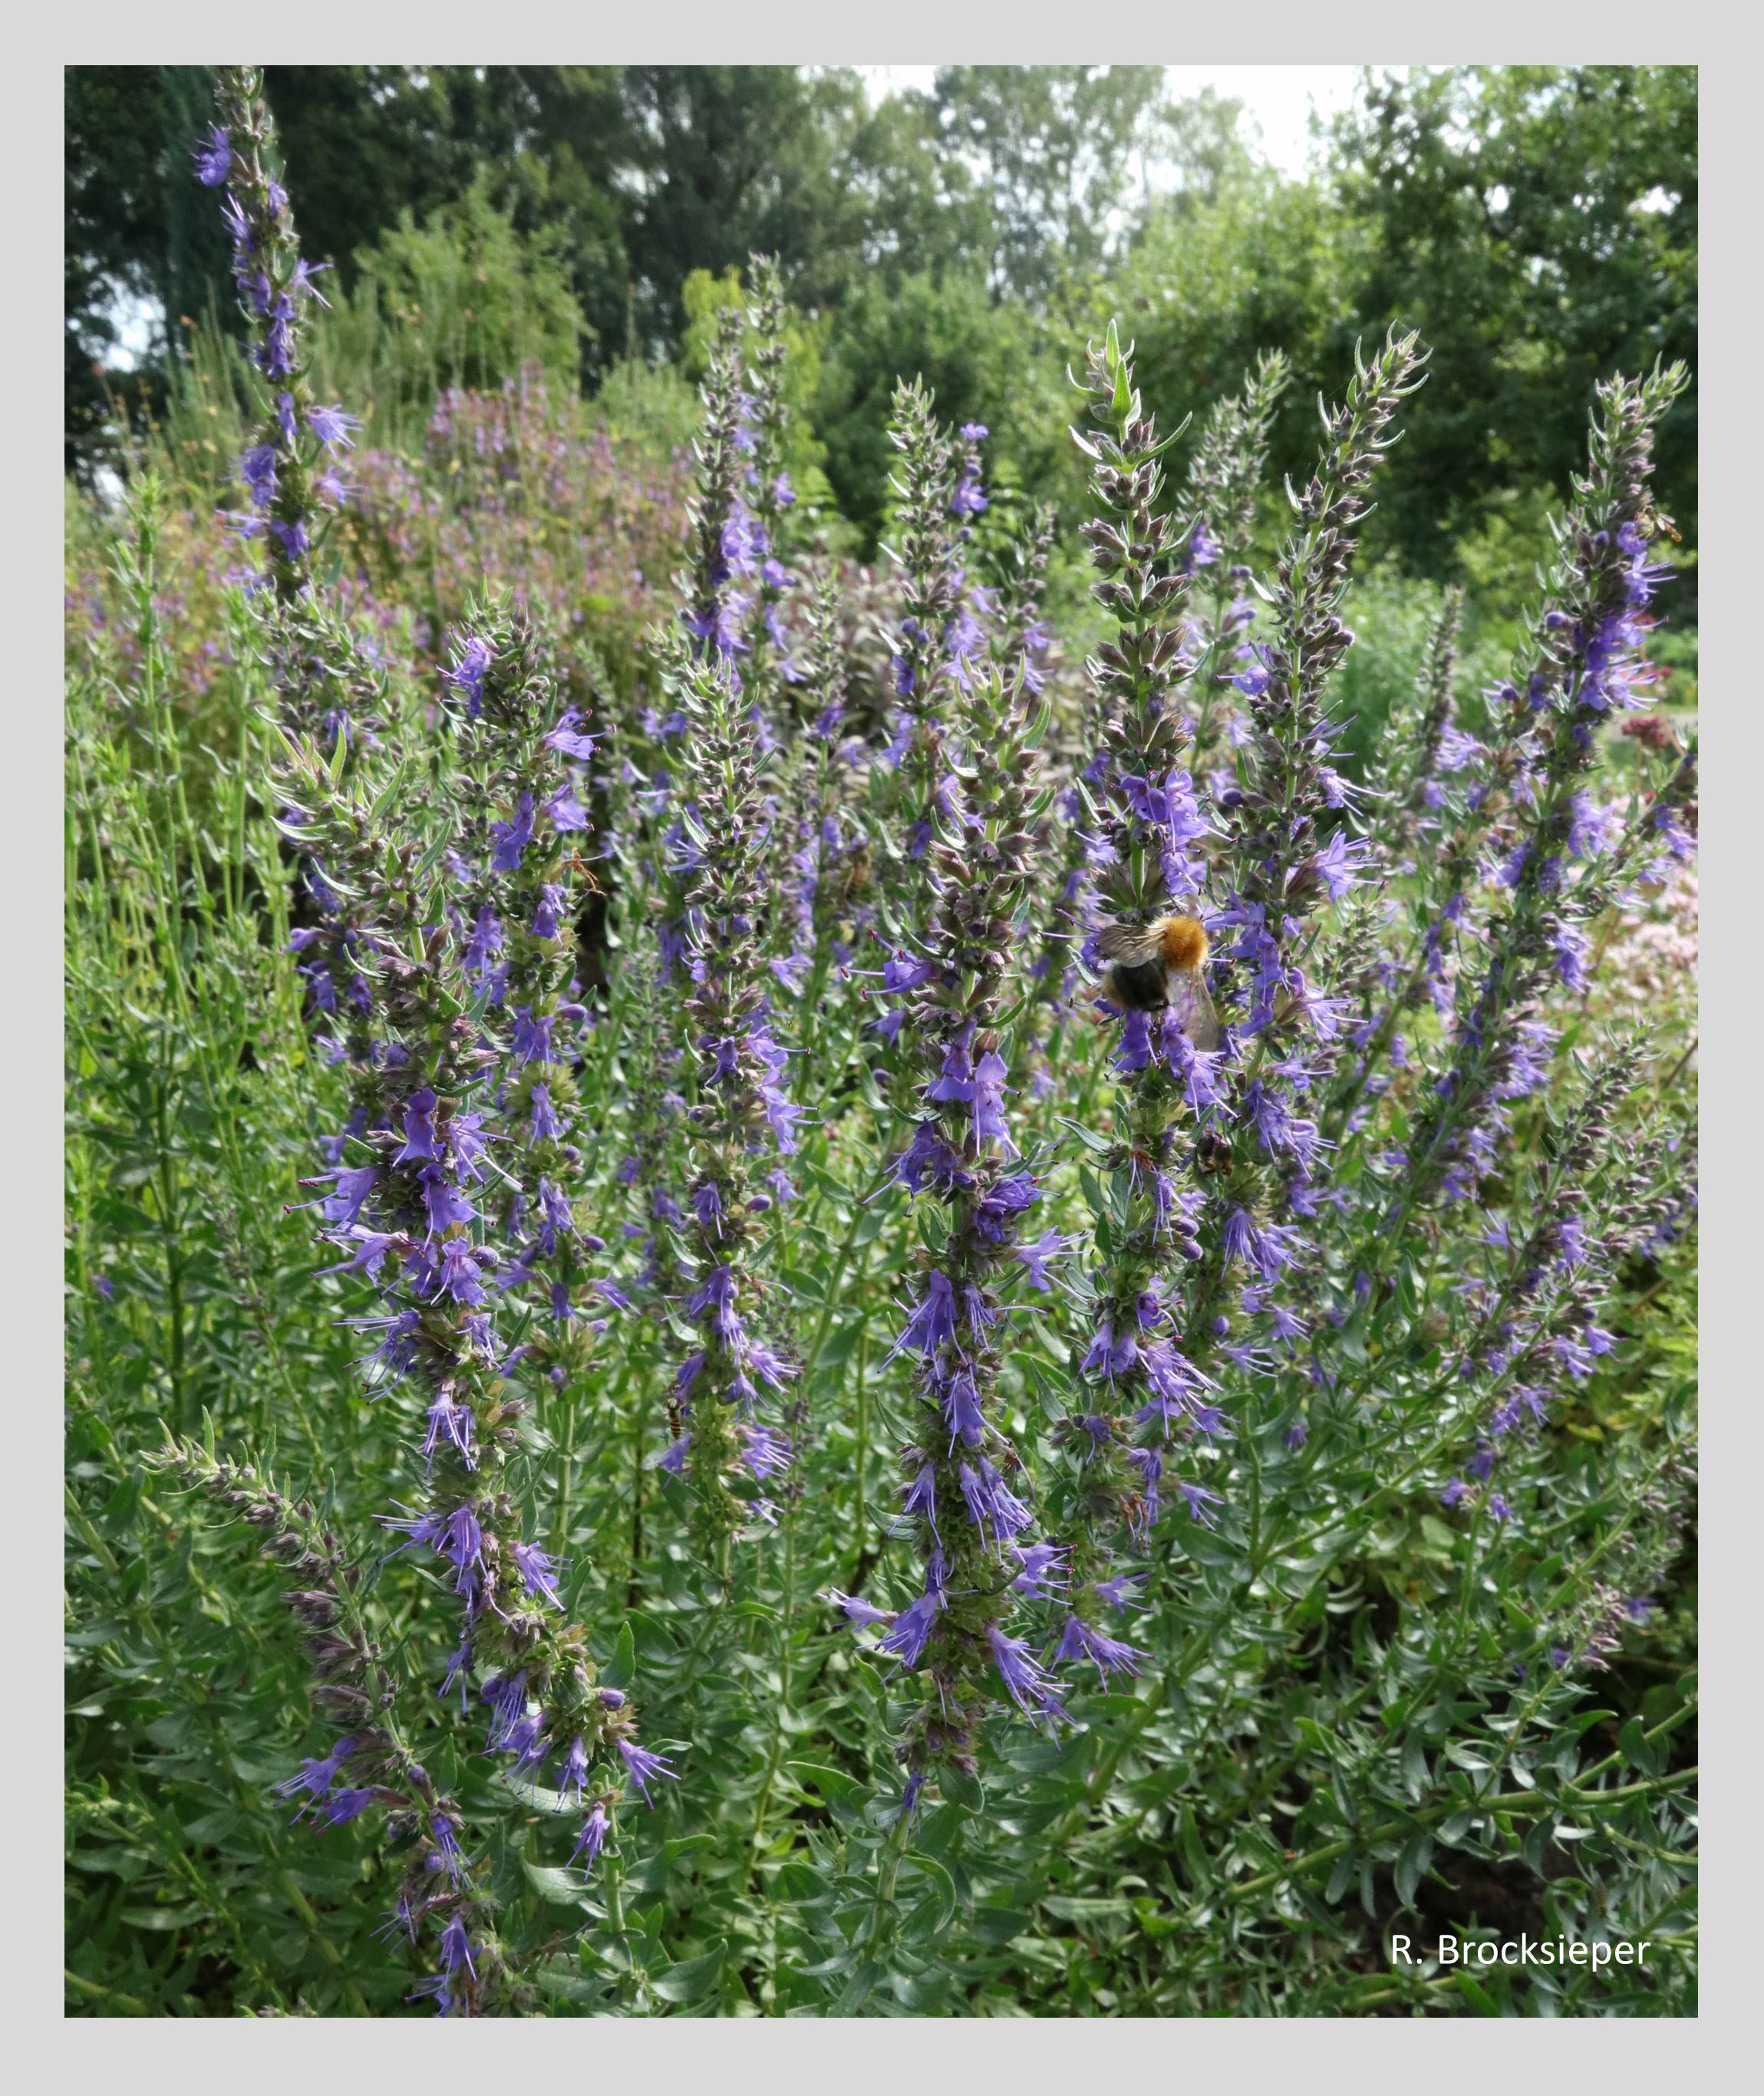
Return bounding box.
[1330,65,1697,570]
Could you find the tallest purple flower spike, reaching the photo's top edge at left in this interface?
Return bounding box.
[195,65,358,602]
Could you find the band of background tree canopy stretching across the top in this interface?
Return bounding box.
[65,65,1697,573]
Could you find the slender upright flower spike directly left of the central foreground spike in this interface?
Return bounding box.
[664,662,798,1578]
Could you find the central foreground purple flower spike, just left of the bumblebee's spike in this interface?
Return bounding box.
[834,671,1064,1809]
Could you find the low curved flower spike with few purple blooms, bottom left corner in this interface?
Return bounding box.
[149,1436,515,2016]
